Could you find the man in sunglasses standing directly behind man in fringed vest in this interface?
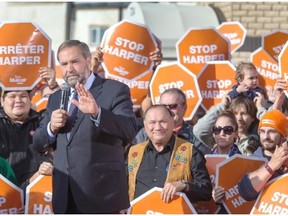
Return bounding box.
[132,88,211,155]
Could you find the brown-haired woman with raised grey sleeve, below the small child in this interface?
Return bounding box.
[193,95,260,155]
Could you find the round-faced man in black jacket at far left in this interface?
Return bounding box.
[0,90,52,189]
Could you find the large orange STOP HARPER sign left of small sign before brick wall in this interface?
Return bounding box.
[176,28,231,75]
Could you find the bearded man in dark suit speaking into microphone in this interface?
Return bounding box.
[33,40,136,213]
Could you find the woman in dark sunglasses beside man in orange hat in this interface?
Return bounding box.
[212,110,241,214]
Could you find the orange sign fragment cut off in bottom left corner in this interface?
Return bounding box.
[0,174,24,214]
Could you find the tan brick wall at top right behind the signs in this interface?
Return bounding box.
[199,2,288,65]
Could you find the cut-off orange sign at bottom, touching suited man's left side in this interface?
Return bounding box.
[25,175,53,214]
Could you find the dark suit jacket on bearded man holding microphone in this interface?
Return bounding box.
[33,76,136,213]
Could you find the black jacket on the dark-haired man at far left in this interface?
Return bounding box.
[0,107,49,189]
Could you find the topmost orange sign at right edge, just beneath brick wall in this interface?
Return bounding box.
[262,31,288,61]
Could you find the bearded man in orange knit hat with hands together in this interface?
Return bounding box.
[238,110,288,201]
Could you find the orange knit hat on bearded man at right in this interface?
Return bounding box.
[258,110,288,137]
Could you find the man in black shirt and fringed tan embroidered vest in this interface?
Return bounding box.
[128,104,212,203]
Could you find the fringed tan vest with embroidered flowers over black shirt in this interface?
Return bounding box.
[128,137,193,201]
